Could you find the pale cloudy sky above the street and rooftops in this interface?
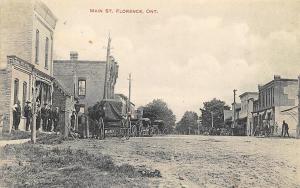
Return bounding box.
[43,0,300,121]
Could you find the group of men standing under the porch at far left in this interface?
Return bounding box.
[13,101,59,132]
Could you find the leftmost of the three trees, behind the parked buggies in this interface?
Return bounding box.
[143,99,176,133]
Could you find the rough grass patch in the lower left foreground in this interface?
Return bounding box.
[0,143,148,187]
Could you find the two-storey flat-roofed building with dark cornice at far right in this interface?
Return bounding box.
[253,76,299,136]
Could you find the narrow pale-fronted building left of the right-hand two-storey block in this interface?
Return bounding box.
[239,92,258,136]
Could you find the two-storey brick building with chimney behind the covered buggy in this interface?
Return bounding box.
[53,41,119,113]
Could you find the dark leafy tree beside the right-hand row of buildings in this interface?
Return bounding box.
[200,98,230,127]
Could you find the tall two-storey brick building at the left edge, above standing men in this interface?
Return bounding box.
[0,0,57,132]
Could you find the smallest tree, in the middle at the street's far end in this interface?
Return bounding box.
[176,111,198,134]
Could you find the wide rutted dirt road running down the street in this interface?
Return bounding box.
[59,136,300,187]
